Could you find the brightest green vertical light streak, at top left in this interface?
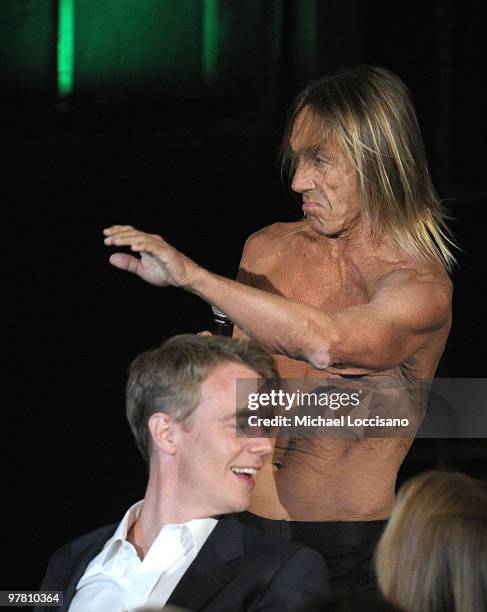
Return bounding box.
[57,0,74,98]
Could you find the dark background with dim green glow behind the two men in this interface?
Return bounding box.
[0,0,487,589]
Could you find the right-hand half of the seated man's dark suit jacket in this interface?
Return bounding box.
[170,513,328,612]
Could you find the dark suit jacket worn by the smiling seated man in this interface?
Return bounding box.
[36,515,328,612]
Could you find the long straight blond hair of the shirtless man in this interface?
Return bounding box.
[282,66,455,270]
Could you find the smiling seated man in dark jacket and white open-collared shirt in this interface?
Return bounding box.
[41,334,327,612]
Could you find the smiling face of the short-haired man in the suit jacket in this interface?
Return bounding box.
[176,362,273,517]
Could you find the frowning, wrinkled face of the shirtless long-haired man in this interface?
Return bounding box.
[290,108,362,236]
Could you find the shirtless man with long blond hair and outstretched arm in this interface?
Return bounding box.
[104,66,454,587]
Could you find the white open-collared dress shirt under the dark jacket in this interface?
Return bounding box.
[69,500,217,612]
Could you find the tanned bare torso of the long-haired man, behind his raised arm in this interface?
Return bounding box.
[236,222,450,521]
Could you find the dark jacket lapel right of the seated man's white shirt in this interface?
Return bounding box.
[167,515,244,610]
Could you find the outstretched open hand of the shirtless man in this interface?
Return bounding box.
[103,225,199,287]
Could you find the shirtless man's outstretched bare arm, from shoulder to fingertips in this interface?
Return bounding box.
[104,225,451,371]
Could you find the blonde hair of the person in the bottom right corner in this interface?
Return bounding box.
[376,471,487,612]
